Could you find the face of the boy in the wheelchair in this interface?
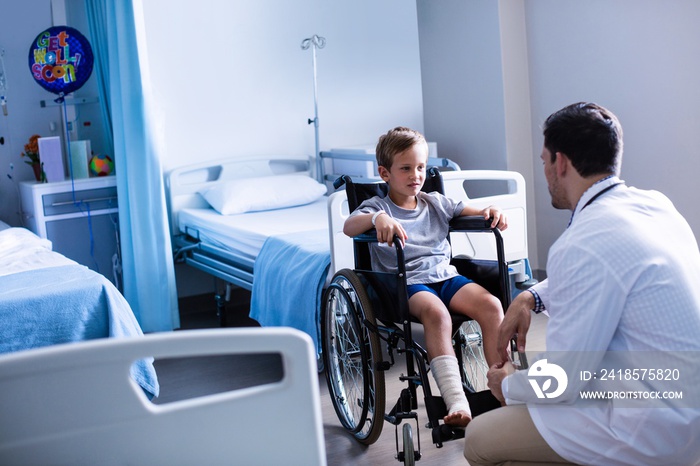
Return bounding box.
[379,143,428,198]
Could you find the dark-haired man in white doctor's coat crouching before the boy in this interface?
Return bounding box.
[464,103,700,466]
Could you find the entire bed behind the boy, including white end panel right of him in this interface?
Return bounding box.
[166,152,531,351]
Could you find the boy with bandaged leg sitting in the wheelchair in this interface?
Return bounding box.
[343,127,508,427]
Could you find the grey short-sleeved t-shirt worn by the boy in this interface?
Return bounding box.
[351,191,464,285]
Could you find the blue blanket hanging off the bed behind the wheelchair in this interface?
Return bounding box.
[250,230,331,354]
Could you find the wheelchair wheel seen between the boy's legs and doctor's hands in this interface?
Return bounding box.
[455,320,489,393]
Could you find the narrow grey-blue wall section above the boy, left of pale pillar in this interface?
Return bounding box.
[417,0,507,170]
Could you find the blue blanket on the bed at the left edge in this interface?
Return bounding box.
[0,265,159,396]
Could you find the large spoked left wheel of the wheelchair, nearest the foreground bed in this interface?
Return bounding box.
[321,269,385,445]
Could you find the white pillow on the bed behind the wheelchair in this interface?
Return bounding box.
[199,175,326,215]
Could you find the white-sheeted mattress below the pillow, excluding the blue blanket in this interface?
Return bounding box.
[178,197,328,260]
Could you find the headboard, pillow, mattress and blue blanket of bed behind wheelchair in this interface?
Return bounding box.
[166,157,330,345]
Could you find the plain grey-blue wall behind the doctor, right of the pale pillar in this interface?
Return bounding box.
[525,0,700,264]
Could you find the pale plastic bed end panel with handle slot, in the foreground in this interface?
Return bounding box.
[0,328,326,466]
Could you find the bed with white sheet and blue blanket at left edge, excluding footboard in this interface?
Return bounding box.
[0,221,160,397]
